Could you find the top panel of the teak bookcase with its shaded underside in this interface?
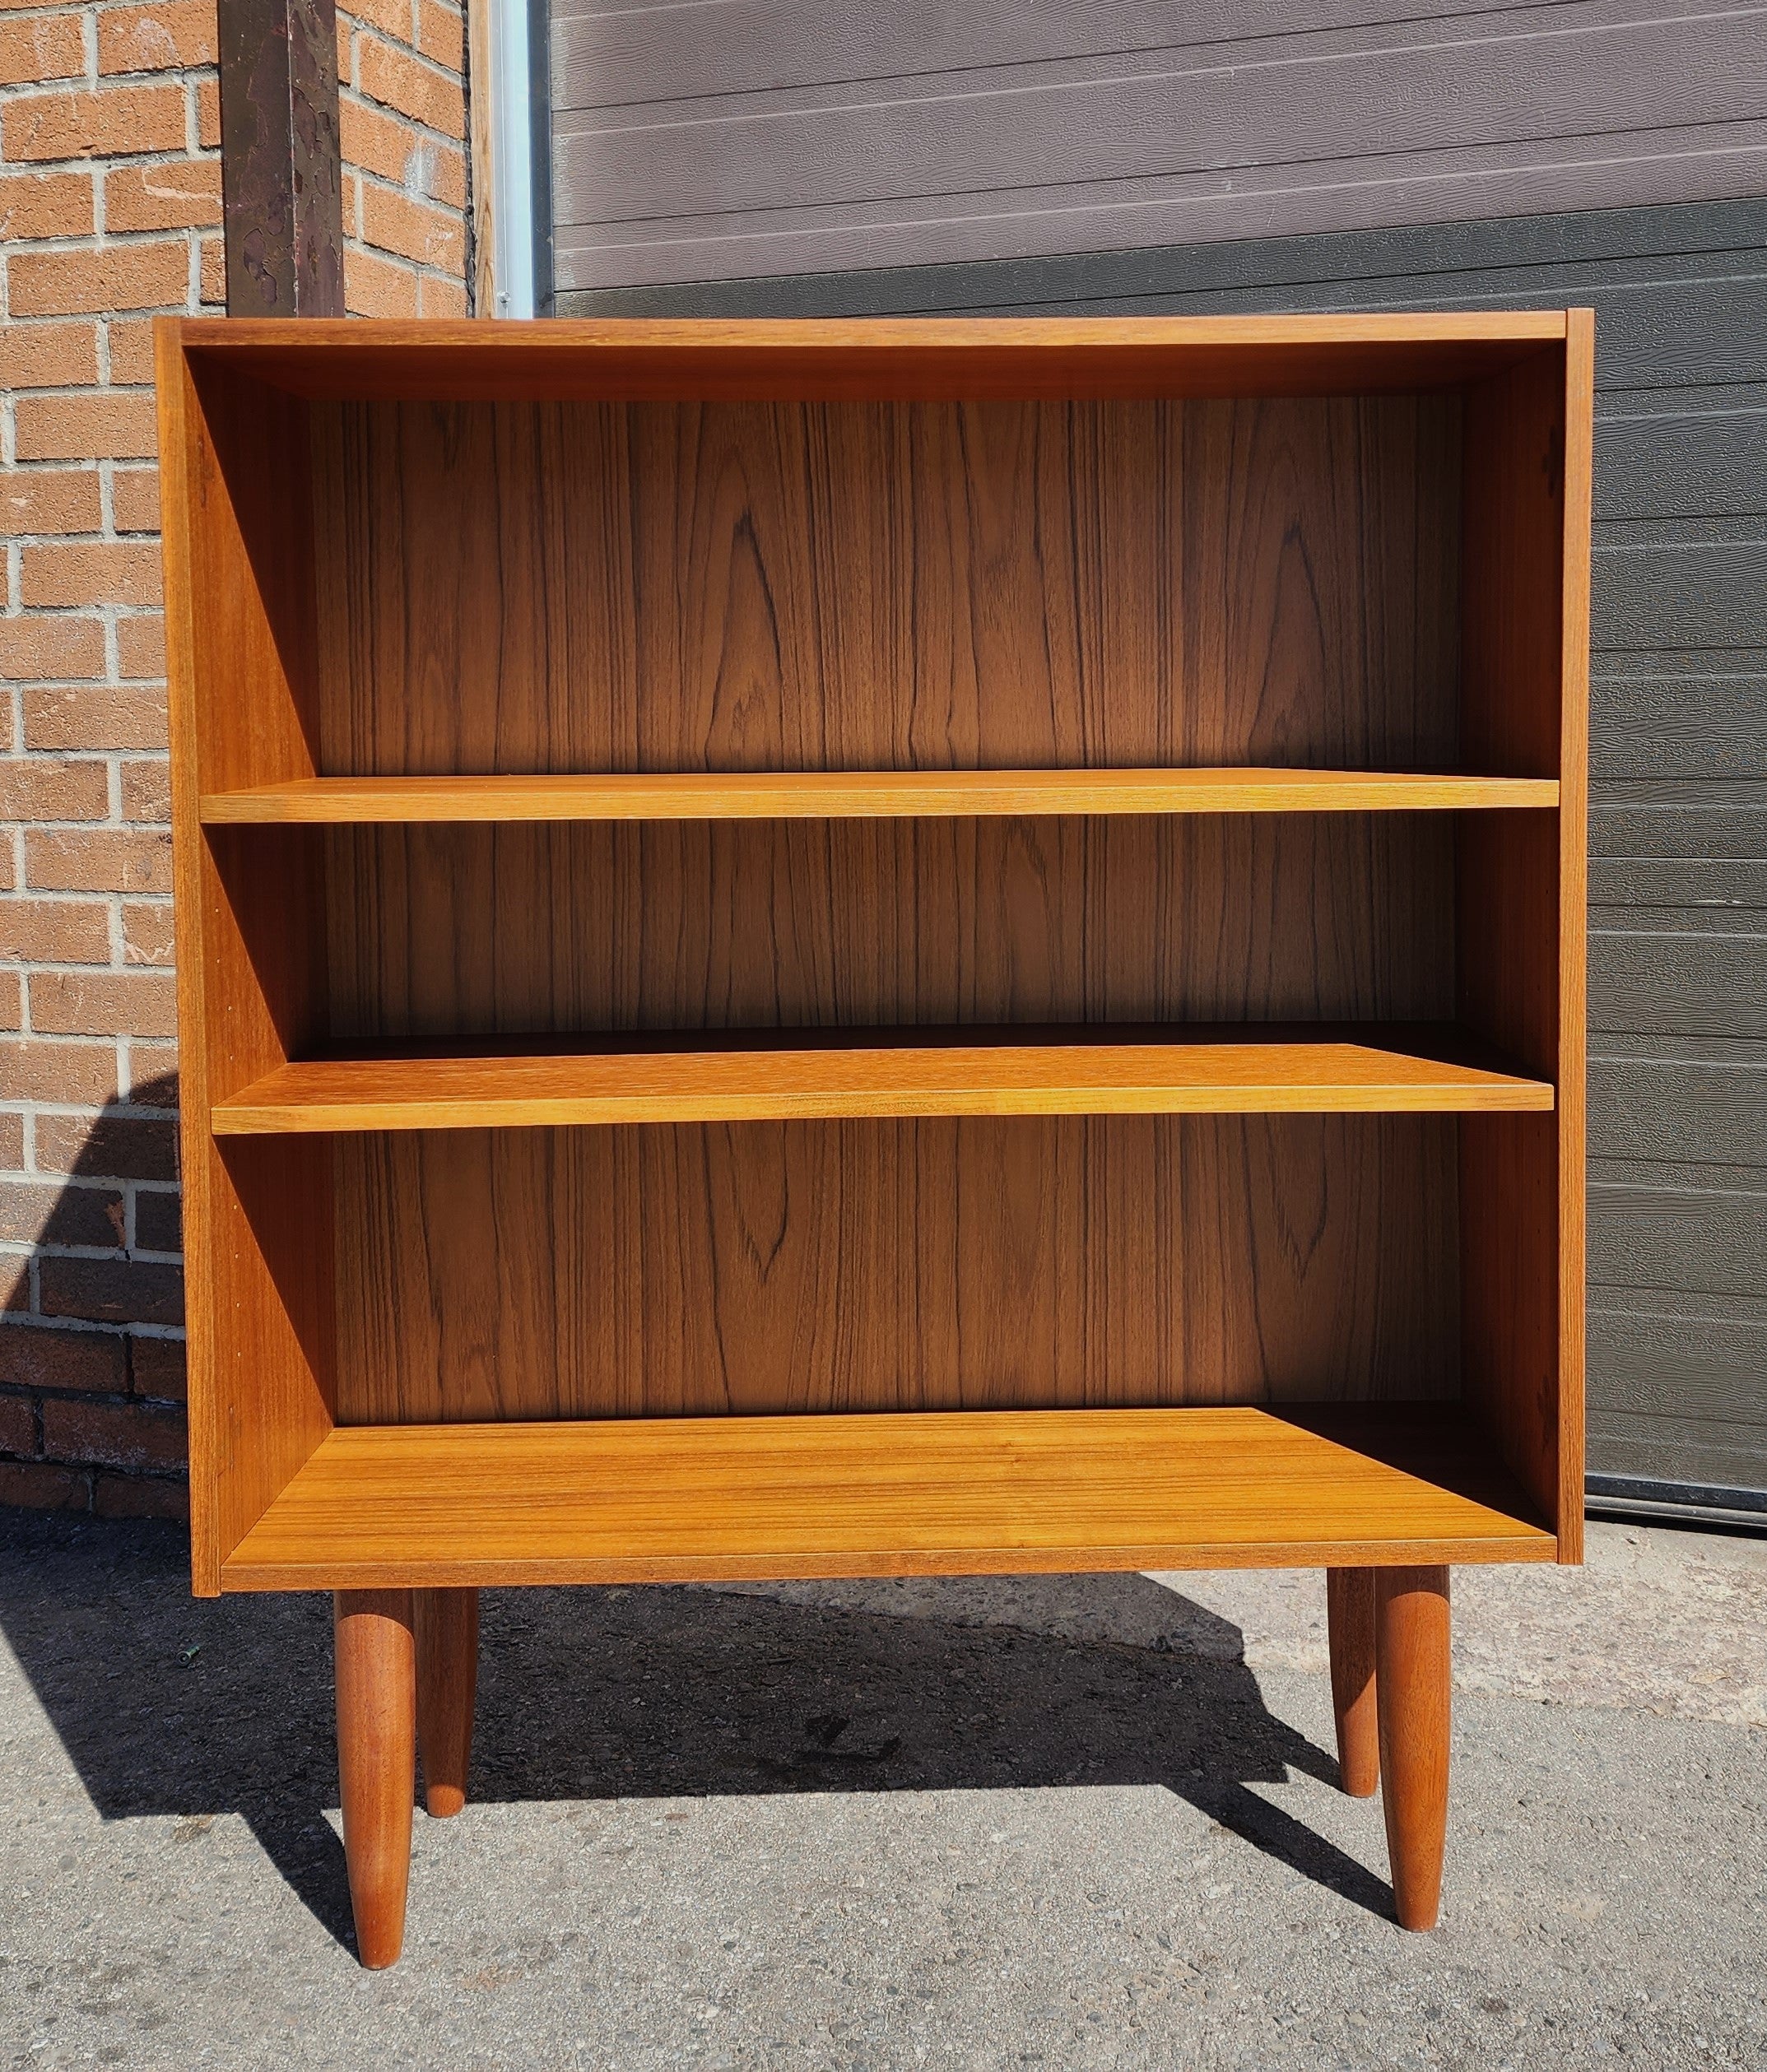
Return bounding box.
[151,311,1566,402]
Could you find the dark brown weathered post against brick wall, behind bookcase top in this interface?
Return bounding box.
[220,0,344,317]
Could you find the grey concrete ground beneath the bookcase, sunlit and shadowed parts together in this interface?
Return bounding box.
[0,1515,1767,2072]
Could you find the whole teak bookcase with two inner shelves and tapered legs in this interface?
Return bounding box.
[160,311,1591,1964]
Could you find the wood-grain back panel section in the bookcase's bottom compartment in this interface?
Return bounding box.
[333,1115,1458,1424]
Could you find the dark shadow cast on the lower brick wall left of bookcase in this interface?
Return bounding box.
[0,1075,188,1517]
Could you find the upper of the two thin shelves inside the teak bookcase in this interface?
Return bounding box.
[201,769,1558,825]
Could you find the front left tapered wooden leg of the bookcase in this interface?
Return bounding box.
[332,1589,416,1971]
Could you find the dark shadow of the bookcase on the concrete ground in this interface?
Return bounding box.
[0,1512,1390,1945]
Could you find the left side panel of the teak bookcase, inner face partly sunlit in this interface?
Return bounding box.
[160,339,333,1591]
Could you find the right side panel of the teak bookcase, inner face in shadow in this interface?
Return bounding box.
[1456,348,1587,1552]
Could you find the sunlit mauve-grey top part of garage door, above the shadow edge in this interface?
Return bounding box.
[551,0,1767,288]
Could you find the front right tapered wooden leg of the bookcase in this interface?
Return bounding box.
[1374,1568,1450,1929]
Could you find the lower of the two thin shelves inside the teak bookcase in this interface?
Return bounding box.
[212,1025,1554,1136]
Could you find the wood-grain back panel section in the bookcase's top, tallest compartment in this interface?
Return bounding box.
[313,392,1460,775]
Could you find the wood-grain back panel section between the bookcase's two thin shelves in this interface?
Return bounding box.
[323,815,1454,1040]
